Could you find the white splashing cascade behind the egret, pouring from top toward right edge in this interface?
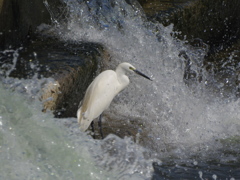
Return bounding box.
[48,1,240,156]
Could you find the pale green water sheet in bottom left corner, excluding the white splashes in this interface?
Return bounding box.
[0,85,105,179]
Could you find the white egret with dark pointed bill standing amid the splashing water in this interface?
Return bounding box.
[77,62,152,138]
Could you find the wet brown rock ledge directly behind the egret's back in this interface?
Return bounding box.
[5,38,109,117]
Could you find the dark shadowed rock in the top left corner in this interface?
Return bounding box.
[0,0,64,49]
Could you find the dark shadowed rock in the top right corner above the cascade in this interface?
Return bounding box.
[143,0,240,52]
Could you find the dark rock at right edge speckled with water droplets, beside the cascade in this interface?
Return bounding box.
[205,40,240,98]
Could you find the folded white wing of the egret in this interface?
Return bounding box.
[77,70,118,131]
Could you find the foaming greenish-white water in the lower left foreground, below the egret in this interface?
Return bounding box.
[0,46,152,180]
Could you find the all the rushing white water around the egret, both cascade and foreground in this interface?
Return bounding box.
[0,0,240,180]
